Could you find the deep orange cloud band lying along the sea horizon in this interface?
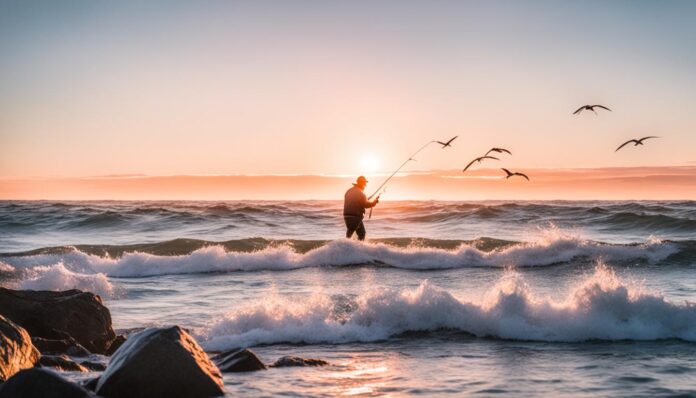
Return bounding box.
[0,166,696,200]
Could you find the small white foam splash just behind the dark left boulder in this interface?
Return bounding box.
[18,263,116,297]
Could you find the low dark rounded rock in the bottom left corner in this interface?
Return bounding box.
[0,368,94,398]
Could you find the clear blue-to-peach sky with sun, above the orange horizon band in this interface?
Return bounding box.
[0,0,696,198]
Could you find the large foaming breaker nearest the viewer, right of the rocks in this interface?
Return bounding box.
[199,265,696,350]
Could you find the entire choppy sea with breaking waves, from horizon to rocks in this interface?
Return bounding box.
[0,201,696,397]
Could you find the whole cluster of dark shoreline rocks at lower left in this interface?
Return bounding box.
[0,288,327,398]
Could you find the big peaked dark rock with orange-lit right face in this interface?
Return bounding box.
[95,326,224,398]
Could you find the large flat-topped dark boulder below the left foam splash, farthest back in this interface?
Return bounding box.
[0,288,116,354]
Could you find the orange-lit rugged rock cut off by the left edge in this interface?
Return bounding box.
[0,315,41,383]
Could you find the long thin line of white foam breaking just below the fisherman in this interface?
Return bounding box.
[3,233,678,277]
